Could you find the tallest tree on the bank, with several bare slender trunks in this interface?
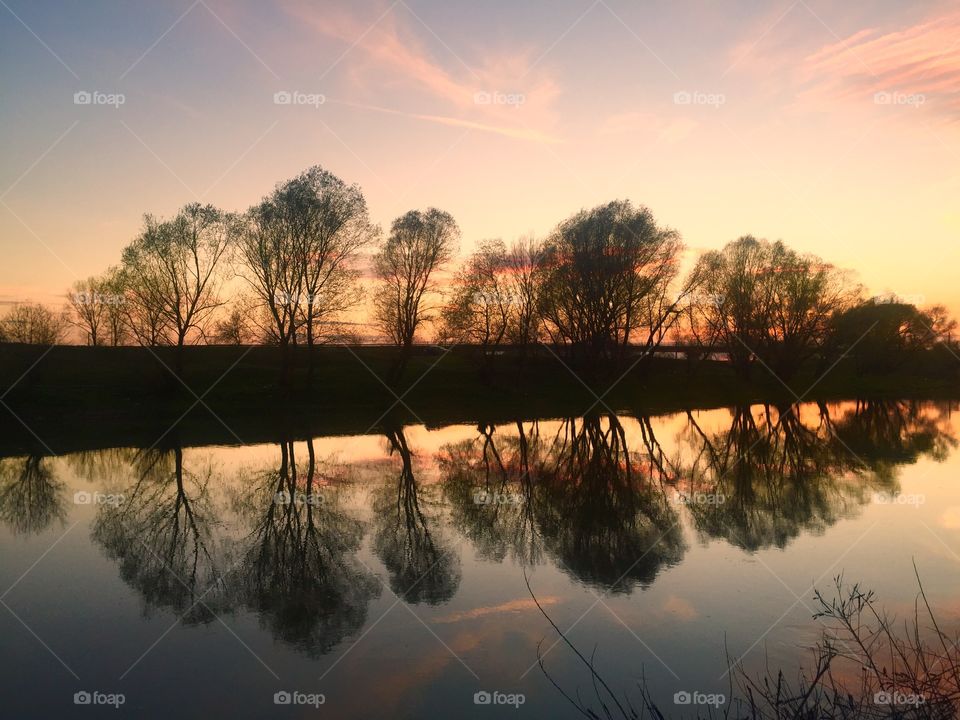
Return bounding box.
[239,166,379,346]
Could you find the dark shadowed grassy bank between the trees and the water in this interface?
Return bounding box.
[0,345,960,455]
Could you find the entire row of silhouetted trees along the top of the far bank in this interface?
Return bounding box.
[0,167,954,377]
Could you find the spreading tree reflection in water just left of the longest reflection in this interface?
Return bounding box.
[93,448,226,623]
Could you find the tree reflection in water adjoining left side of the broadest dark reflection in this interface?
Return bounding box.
[440,422,543,564]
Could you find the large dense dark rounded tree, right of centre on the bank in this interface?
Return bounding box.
[541,200,683,362]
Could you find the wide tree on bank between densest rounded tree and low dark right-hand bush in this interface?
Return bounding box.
[695,235,860,379]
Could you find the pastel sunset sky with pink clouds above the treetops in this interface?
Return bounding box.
[0,0,960,315]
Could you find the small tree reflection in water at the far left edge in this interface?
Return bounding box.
[0,455,67,534]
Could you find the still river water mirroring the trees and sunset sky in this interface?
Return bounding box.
[0,402,960,718]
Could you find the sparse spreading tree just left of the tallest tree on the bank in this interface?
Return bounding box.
[123,203,232,347]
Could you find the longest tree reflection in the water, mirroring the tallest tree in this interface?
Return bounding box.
[232,441,380,655]
